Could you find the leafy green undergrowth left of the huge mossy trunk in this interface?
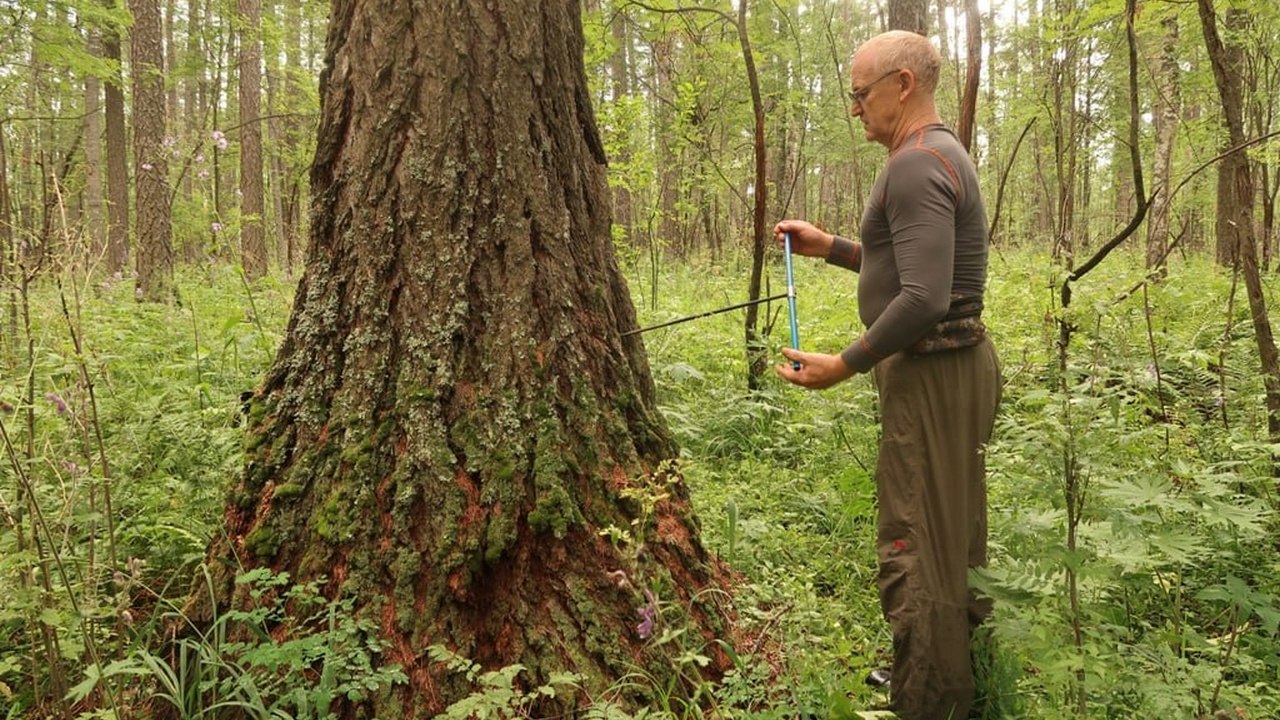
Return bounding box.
[0,268,288,708]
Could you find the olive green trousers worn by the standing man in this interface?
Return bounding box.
[876,340,1002,720]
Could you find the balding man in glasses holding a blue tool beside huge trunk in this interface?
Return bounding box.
[774,32,1001,720]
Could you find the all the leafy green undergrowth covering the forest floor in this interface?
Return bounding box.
[0,251,1280,719]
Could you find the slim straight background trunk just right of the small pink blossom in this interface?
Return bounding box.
[239,0,266,279]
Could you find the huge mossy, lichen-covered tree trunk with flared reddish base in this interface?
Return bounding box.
[193,0,728,717]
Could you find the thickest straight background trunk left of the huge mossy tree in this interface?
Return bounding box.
[129,0,173,302]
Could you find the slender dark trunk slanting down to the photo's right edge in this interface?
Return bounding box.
[1198,0,1280,453]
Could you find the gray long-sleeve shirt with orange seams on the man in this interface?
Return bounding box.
[827,124,987,373]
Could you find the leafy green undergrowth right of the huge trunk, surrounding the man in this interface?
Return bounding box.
[627,244,1280,717]
